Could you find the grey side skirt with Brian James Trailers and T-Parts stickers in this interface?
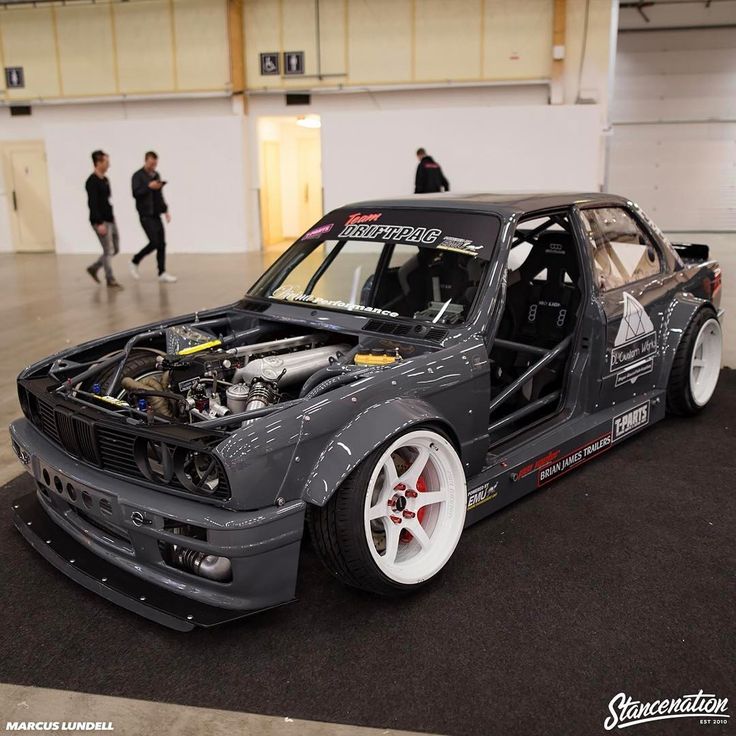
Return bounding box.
[465,391,665,527]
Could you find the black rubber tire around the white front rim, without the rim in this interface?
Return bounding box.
[307,427,466,597]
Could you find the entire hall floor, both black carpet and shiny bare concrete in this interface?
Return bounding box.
[0,249,736,736]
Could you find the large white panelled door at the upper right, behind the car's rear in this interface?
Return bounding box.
[609,28,736,231]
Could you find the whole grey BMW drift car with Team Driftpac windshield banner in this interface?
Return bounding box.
[11,194,721,630]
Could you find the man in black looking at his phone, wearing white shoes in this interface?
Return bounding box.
[130,151,176,284]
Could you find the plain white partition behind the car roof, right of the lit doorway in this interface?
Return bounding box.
[322,105,601,209]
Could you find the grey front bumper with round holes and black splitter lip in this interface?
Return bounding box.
[10,419,305,631]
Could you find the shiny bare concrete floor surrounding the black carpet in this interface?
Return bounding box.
[0,233,736,736]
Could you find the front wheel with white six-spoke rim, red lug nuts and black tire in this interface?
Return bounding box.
[309,427,467,595]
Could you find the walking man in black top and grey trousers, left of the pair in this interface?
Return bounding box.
[84,151,123,289]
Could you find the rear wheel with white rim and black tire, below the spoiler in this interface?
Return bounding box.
[667,308,723,416]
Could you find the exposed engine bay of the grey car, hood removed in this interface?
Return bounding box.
[49,318,402,427]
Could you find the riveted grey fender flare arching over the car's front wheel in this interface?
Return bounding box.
[302,397,457,506]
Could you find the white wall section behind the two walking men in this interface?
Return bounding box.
[0,98,247,253]
